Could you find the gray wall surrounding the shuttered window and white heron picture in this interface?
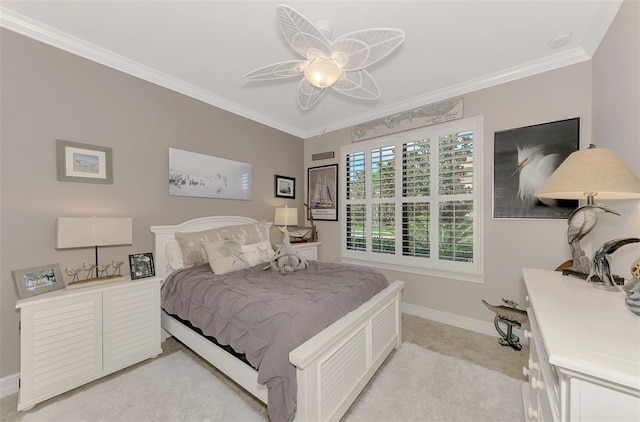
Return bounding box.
[305,62,591,322]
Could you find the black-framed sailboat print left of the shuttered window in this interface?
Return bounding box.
[307,164,338,221]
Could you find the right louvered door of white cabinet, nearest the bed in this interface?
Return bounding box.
[103,282,161,372]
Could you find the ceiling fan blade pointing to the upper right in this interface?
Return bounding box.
[331,28,404,71]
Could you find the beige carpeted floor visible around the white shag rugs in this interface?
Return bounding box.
[0,314,529,422]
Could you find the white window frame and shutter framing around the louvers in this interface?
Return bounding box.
[339,117,485,283]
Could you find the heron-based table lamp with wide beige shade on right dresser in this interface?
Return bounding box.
[535,144,640,278]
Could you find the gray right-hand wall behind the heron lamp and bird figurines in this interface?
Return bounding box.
[592,1,640,268]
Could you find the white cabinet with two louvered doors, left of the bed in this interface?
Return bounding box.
[16,277,162,410]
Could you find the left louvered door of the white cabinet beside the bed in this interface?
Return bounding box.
[18,292,102,410]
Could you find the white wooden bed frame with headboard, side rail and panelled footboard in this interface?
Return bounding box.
[151,216,404,421]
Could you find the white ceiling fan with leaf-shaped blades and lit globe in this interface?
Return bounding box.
[243,5,404,110]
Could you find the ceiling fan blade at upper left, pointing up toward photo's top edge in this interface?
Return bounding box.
[276,4,331,58]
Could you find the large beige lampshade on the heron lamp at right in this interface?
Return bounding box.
[535,145,640,199]
